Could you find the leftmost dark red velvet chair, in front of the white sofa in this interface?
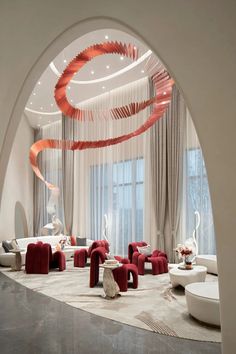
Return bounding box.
[25,242,66,274]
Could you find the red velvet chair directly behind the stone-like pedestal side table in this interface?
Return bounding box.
[89,247,138,291]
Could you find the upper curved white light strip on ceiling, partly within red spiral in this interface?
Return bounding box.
[50,50,152,85]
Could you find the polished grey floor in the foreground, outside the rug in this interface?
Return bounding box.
[0,273,221,354]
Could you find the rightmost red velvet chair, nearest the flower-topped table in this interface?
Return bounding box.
[128,241,168,275]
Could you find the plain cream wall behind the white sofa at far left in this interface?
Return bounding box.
[0,116,34,241]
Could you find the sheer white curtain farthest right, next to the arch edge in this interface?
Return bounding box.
[178,111,216,254]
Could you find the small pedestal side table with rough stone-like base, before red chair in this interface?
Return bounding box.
[100,263,122,299]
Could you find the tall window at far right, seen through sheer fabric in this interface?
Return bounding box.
[186,148,216,254]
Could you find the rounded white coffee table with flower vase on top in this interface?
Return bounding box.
[169,265,207,288]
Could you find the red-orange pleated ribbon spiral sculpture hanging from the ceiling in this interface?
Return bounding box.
[29,42,174,190]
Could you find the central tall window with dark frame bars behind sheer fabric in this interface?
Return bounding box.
[90,158,144,255]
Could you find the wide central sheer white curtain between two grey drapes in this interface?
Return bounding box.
[73,78,150,255]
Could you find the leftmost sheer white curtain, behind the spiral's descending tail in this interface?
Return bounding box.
[34,120,64,235]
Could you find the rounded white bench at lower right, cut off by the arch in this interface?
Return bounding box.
[185,282,220,326]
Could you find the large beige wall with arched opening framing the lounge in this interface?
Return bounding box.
[0,0,236,354]
